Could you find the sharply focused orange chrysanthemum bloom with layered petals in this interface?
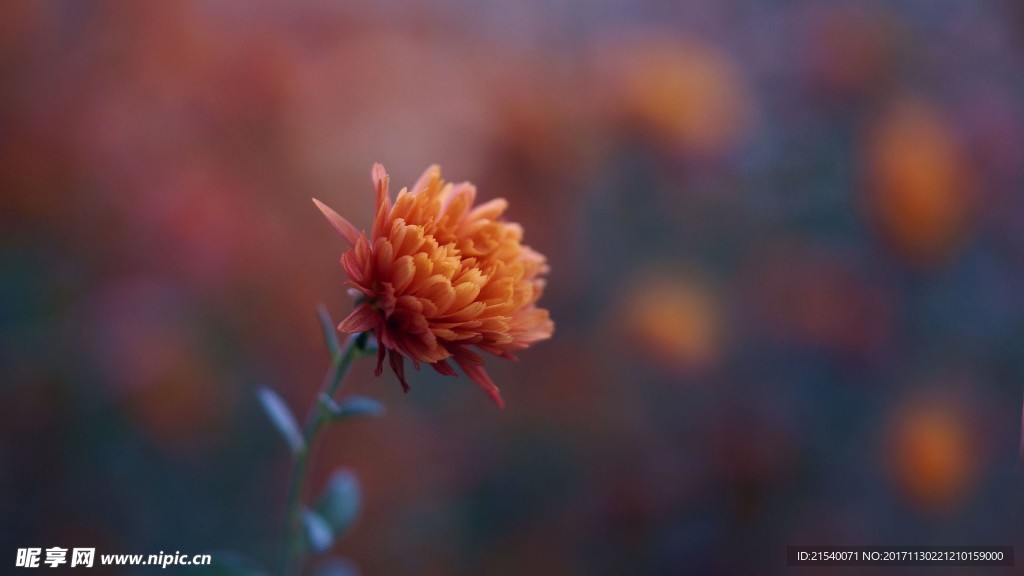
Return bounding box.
[313,164,554,407]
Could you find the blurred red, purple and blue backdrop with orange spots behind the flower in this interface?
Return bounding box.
[6,0,1024,575]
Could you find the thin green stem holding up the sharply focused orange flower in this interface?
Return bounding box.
[281,334,360,576]
